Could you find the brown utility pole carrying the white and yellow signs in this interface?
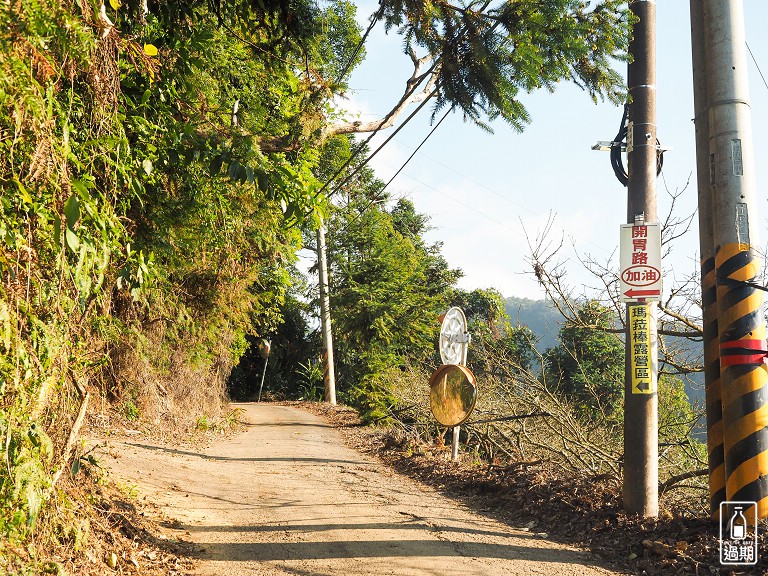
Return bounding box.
[624,0,659,517]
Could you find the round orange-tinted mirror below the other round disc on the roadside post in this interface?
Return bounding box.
[429,364,477,427]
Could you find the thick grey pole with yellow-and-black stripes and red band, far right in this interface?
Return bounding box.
[694,0,768,518]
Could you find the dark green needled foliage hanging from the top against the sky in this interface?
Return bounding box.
[382,0,630,130]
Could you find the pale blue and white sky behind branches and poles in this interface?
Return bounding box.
[310,0,768,299]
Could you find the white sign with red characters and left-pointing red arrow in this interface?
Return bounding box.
[619,222,661,302]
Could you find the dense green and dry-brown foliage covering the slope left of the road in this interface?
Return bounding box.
[0,0,352,564]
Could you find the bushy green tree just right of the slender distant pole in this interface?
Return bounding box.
[328,187,460,418]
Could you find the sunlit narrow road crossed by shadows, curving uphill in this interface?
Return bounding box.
[97,404,624,576]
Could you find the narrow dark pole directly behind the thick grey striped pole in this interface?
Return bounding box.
[690,0,726,519]
